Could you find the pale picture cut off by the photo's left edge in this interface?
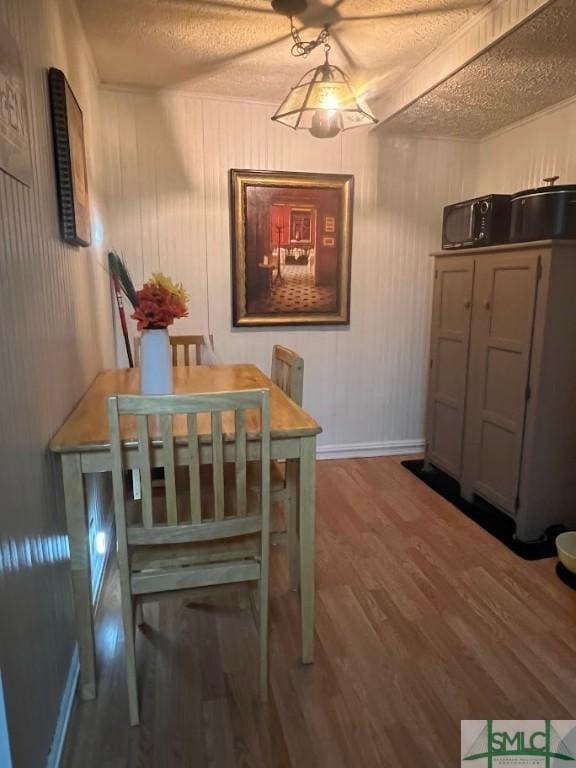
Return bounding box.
[0,21,32,186]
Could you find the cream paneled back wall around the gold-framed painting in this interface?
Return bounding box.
[101,89,476,455]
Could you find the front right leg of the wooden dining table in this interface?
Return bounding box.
[299,436,316,664]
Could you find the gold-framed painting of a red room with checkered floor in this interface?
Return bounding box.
[230,169,354,326]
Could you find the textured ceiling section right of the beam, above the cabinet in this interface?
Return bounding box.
[387,0,576,138]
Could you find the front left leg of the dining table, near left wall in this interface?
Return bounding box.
[62,453,96,700]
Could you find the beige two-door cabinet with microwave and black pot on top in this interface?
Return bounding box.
[426,242,576,541]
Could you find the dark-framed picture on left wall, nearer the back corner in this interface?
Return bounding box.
[48,68,91,246]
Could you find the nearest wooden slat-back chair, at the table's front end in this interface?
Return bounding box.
[108,390,270,725]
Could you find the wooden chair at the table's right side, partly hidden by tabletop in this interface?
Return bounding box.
[270,344,304,590]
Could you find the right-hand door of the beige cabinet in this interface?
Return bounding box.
[462,252,540,513]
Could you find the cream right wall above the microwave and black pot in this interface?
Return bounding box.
[469,99,576,194]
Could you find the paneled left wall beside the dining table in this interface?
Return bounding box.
[0,0,113,768]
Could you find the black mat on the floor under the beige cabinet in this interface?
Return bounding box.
[402,459,566,560]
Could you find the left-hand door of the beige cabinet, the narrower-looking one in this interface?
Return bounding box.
[426,256,474,479]
